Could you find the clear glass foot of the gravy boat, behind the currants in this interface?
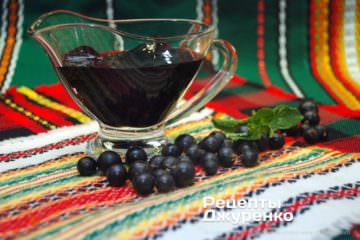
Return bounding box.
[86,131,169,160]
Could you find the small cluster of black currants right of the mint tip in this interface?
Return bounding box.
[296,99,328,144]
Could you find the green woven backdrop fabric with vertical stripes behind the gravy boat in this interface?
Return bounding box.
[0,0,360,109]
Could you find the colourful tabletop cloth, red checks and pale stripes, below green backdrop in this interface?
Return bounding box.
[0,77,360,239]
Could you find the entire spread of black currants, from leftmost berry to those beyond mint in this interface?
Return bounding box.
[77,100,328,195]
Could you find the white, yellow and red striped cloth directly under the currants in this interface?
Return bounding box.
[0,126,360,239]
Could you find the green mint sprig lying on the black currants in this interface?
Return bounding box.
[212,104,303,140]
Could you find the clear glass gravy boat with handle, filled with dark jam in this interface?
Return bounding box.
[28,10,237,155]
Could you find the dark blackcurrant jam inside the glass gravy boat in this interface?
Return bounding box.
[56,43,203,127]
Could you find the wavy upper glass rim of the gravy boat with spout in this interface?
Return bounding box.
[27,10,215,41]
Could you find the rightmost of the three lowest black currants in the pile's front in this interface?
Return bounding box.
[171,162,195,187]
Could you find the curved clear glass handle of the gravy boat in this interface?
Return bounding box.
[166,39,237,125]
